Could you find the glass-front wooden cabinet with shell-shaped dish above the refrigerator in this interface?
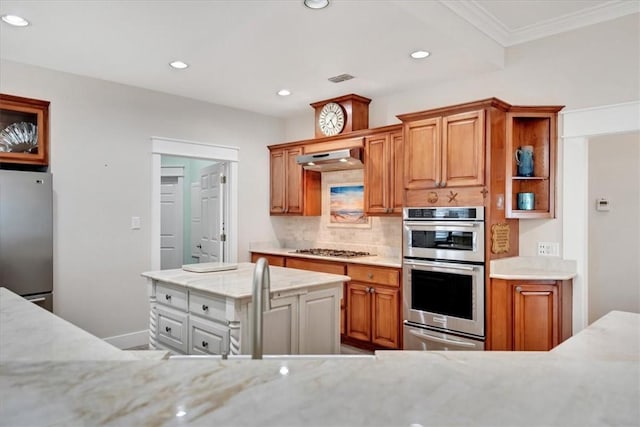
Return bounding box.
[0,94,49,166]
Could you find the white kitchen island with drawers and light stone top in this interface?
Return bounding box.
[142,263,349,355]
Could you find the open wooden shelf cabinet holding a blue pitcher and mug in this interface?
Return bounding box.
[505,106,563,218]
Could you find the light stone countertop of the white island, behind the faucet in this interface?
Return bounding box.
[142,262,351,298]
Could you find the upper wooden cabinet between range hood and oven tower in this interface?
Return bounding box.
[364,129,404,215]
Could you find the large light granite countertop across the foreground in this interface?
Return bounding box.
[0,291,640,427]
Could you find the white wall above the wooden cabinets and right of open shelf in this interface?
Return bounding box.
[285,14,640,255]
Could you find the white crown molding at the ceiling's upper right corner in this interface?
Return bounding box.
[440,0,640,47]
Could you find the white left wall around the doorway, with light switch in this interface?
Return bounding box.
[0,61,283,337]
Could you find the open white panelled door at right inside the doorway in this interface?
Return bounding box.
[200,163,227,262]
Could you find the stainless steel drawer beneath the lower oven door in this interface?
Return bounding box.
[404,323,484,351]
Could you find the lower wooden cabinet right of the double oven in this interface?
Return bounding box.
[488,279,572,351]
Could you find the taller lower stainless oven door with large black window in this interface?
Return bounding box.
[403,259,484,339]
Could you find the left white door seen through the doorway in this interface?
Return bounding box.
[160,170,184,270]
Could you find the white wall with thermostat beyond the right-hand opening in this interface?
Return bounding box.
[588,132,640,323]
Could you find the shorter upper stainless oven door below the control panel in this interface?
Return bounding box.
[403,221,484,262]
